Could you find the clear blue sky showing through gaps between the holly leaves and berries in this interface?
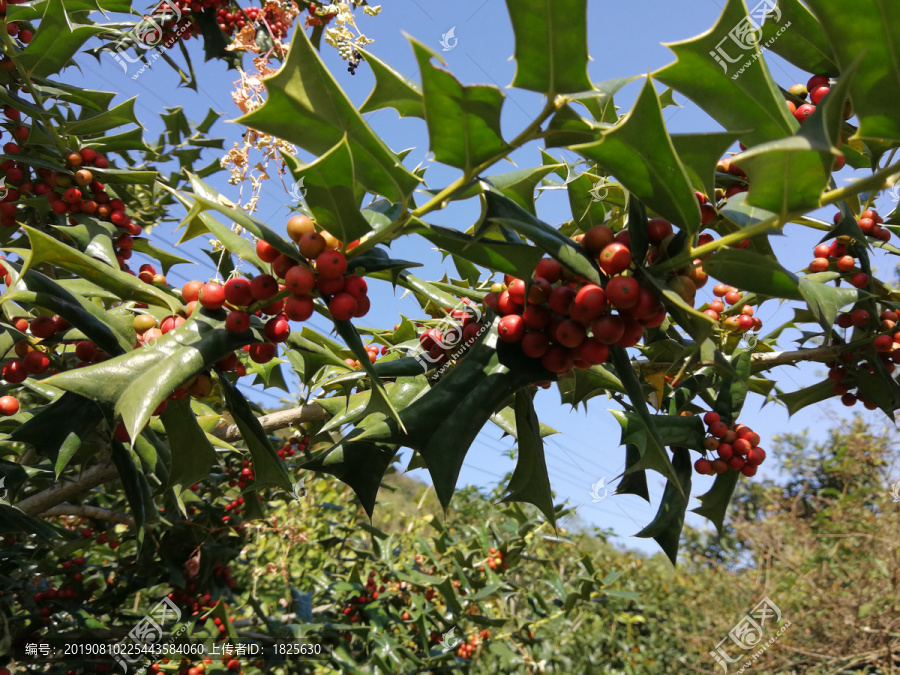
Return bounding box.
[74,0,893,552]
